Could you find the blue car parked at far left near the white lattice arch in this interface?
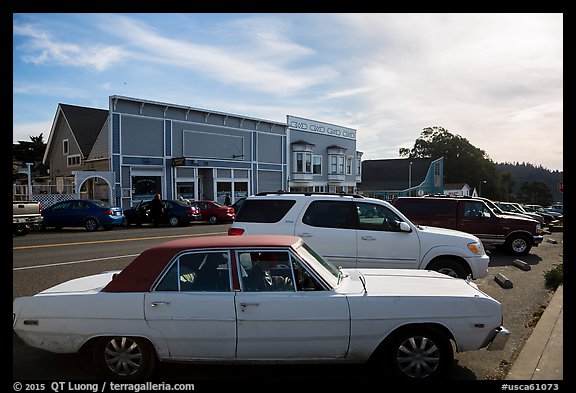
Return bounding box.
[42,199,126,231]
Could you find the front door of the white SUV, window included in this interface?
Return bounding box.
[356,202,420,269]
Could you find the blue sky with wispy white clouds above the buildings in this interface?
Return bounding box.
[13,13,564,171]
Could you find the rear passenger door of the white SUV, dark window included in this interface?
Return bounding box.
[294,200,358,268]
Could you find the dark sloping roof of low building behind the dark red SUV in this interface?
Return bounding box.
[358,158,438,191]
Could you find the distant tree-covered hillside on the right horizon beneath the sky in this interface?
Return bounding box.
[496,163,564,202]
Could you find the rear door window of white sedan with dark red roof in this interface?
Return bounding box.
[155,251,230,292]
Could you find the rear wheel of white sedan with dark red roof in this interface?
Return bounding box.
[93,336,156,380]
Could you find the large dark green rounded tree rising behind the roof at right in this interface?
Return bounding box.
[399,126,503,199]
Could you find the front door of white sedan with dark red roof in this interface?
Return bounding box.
[236,250,350,360]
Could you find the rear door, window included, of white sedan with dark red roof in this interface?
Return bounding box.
[144,251,236,359]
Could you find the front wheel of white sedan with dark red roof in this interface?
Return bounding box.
[384,327,454,381]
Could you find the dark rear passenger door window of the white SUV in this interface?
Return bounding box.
[302,201,358,229]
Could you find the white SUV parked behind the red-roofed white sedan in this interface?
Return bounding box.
[228,192,490,279]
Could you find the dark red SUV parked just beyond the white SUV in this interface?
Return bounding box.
[394,196,543,255]
